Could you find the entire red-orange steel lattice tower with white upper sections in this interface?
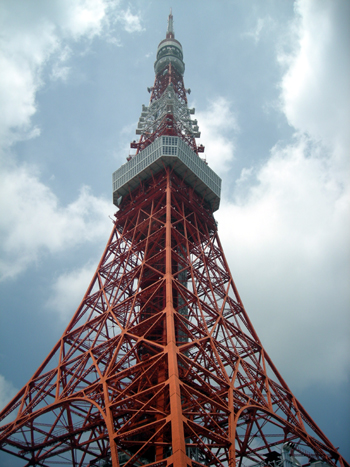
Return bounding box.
[0,12,349,467]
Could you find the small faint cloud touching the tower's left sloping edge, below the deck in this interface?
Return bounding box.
[46,261,97,321]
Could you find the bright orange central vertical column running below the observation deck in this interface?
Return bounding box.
[165,169,187,467]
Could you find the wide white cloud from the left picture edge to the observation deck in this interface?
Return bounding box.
[0,166,112,279]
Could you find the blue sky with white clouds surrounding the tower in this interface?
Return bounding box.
[0,0,350,465]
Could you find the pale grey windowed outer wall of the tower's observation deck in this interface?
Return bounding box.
[113,136,221,212]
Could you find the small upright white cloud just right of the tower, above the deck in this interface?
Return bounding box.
[196,96,239,175]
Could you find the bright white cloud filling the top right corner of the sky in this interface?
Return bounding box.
[279,0,350,165]
